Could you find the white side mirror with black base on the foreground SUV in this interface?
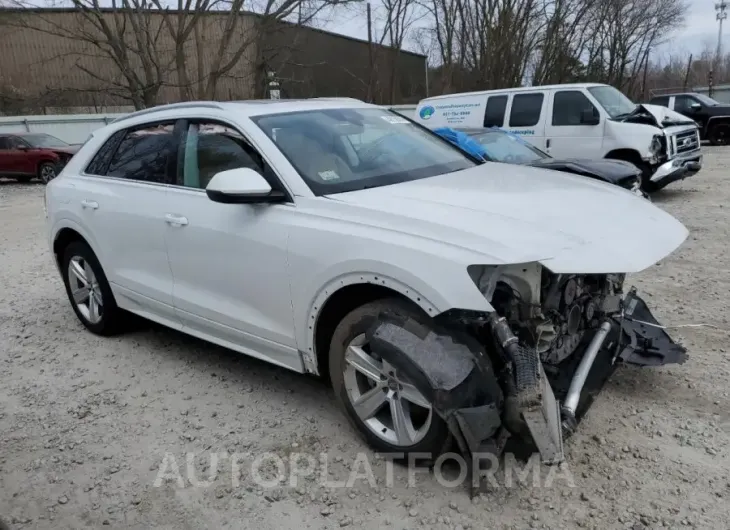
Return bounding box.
[205,167,286,204]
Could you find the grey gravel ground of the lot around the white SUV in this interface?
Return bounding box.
[0,148,730,530]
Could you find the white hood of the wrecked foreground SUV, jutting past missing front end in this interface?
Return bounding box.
[327,163,688,274]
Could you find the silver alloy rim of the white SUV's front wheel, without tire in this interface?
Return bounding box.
[343,334,433,447]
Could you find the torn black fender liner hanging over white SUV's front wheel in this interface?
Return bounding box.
[368,313,503,466]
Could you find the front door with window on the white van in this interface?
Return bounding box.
[545,89,605,158]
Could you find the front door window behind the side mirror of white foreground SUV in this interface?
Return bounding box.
[178,123,266,189]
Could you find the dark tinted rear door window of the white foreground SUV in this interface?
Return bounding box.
[106,123,177,184]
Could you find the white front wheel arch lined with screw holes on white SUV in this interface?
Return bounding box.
[302,273,439,375]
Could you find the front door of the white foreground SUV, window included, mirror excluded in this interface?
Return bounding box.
[165,122,302,370]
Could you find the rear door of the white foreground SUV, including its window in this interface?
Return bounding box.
[74,121,180,327]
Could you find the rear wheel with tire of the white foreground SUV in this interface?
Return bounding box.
[61,241,125,336]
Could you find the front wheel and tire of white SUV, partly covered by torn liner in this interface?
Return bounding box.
[329,298,450,458]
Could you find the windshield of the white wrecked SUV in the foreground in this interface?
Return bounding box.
[252,108,477,195]
